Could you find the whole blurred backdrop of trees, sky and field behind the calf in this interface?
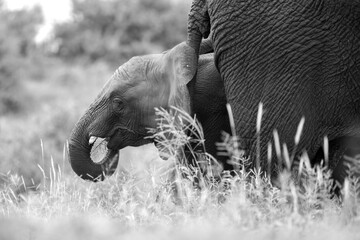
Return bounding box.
[0,0,191,184]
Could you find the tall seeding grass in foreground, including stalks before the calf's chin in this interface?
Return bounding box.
[0,106,360,239]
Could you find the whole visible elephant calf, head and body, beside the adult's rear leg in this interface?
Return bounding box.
[69,41,230,181]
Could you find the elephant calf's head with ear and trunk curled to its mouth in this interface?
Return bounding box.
[69,43,197,181]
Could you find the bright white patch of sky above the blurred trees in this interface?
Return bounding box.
[4,0,71,41]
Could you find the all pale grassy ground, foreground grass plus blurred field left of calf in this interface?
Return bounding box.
[0,58,360,240]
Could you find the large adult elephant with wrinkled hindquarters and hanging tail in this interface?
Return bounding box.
[187,0,360,176]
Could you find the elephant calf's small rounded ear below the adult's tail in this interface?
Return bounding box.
[166,43,197,85]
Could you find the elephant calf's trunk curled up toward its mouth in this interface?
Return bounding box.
[69,114,119,182]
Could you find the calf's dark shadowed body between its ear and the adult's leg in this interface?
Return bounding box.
[190,52,233,170]
